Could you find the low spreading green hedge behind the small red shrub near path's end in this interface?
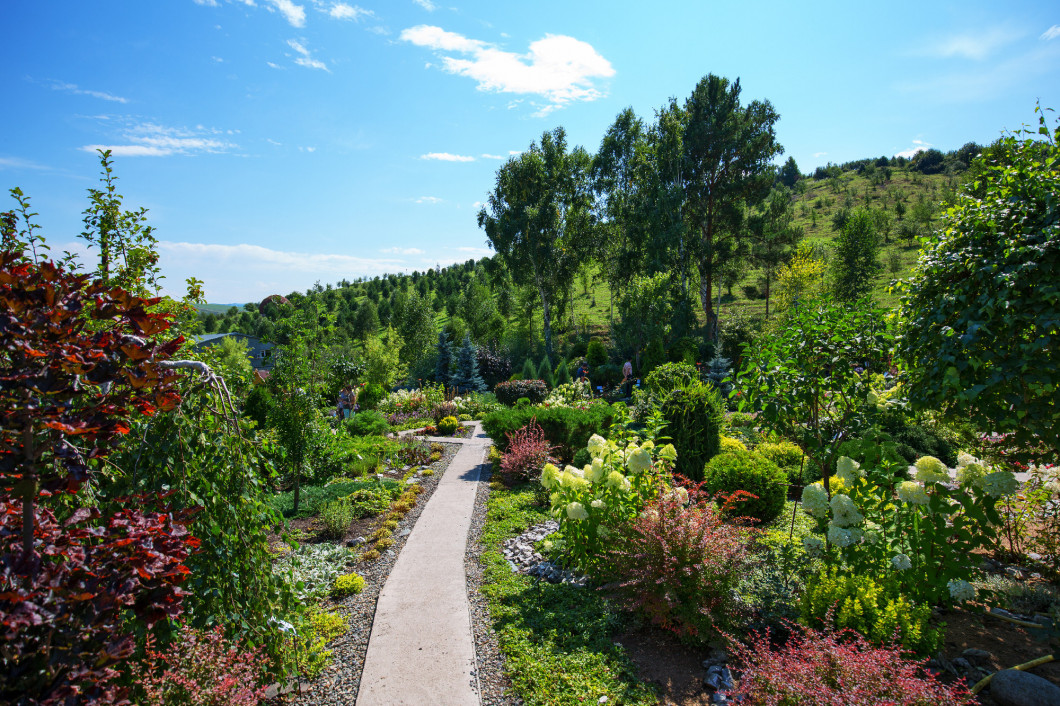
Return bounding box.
[482,404,615,460]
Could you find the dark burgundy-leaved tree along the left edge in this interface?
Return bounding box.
[0,250,198,704]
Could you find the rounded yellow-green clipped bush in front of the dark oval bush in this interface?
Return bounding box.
[703,446,788,525]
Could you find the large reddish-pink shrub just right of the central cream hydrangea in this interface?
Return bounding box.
[604,483,752,637]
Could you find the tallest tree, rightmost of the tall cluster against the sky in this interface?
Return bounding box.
[683,74,783,336]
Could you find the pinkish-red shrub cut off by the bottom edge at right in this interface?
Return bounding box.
[732,625,973,706]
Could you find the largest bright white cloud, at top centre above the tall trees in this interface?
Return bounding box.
[401,24,615,114]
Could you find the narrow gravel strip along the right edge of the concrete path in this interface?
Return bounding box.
[464,451,523,706]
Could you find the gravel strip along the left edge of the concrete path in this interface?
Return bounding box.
[282,442,462,706]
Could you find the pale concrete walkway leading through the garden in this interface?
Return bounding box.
[357,423,490,706]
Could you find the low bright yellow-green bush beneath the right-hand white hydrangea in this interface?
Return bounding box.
[798,568,942,656]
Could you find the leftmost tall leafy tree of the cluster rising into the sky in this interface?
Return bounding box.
[478,127,594,351]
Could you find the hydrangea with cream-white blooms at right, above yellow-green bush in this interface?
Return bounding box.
[802,432,1018,604]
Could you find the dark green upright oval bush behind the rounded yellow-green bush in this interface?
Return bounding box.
[658,379,725,480]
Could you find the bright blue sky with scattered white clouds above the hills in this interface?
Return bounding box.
[0,0,1060,303]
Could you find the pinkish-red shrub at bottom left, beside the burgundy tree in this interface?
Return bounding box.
[131,626,267,706]
